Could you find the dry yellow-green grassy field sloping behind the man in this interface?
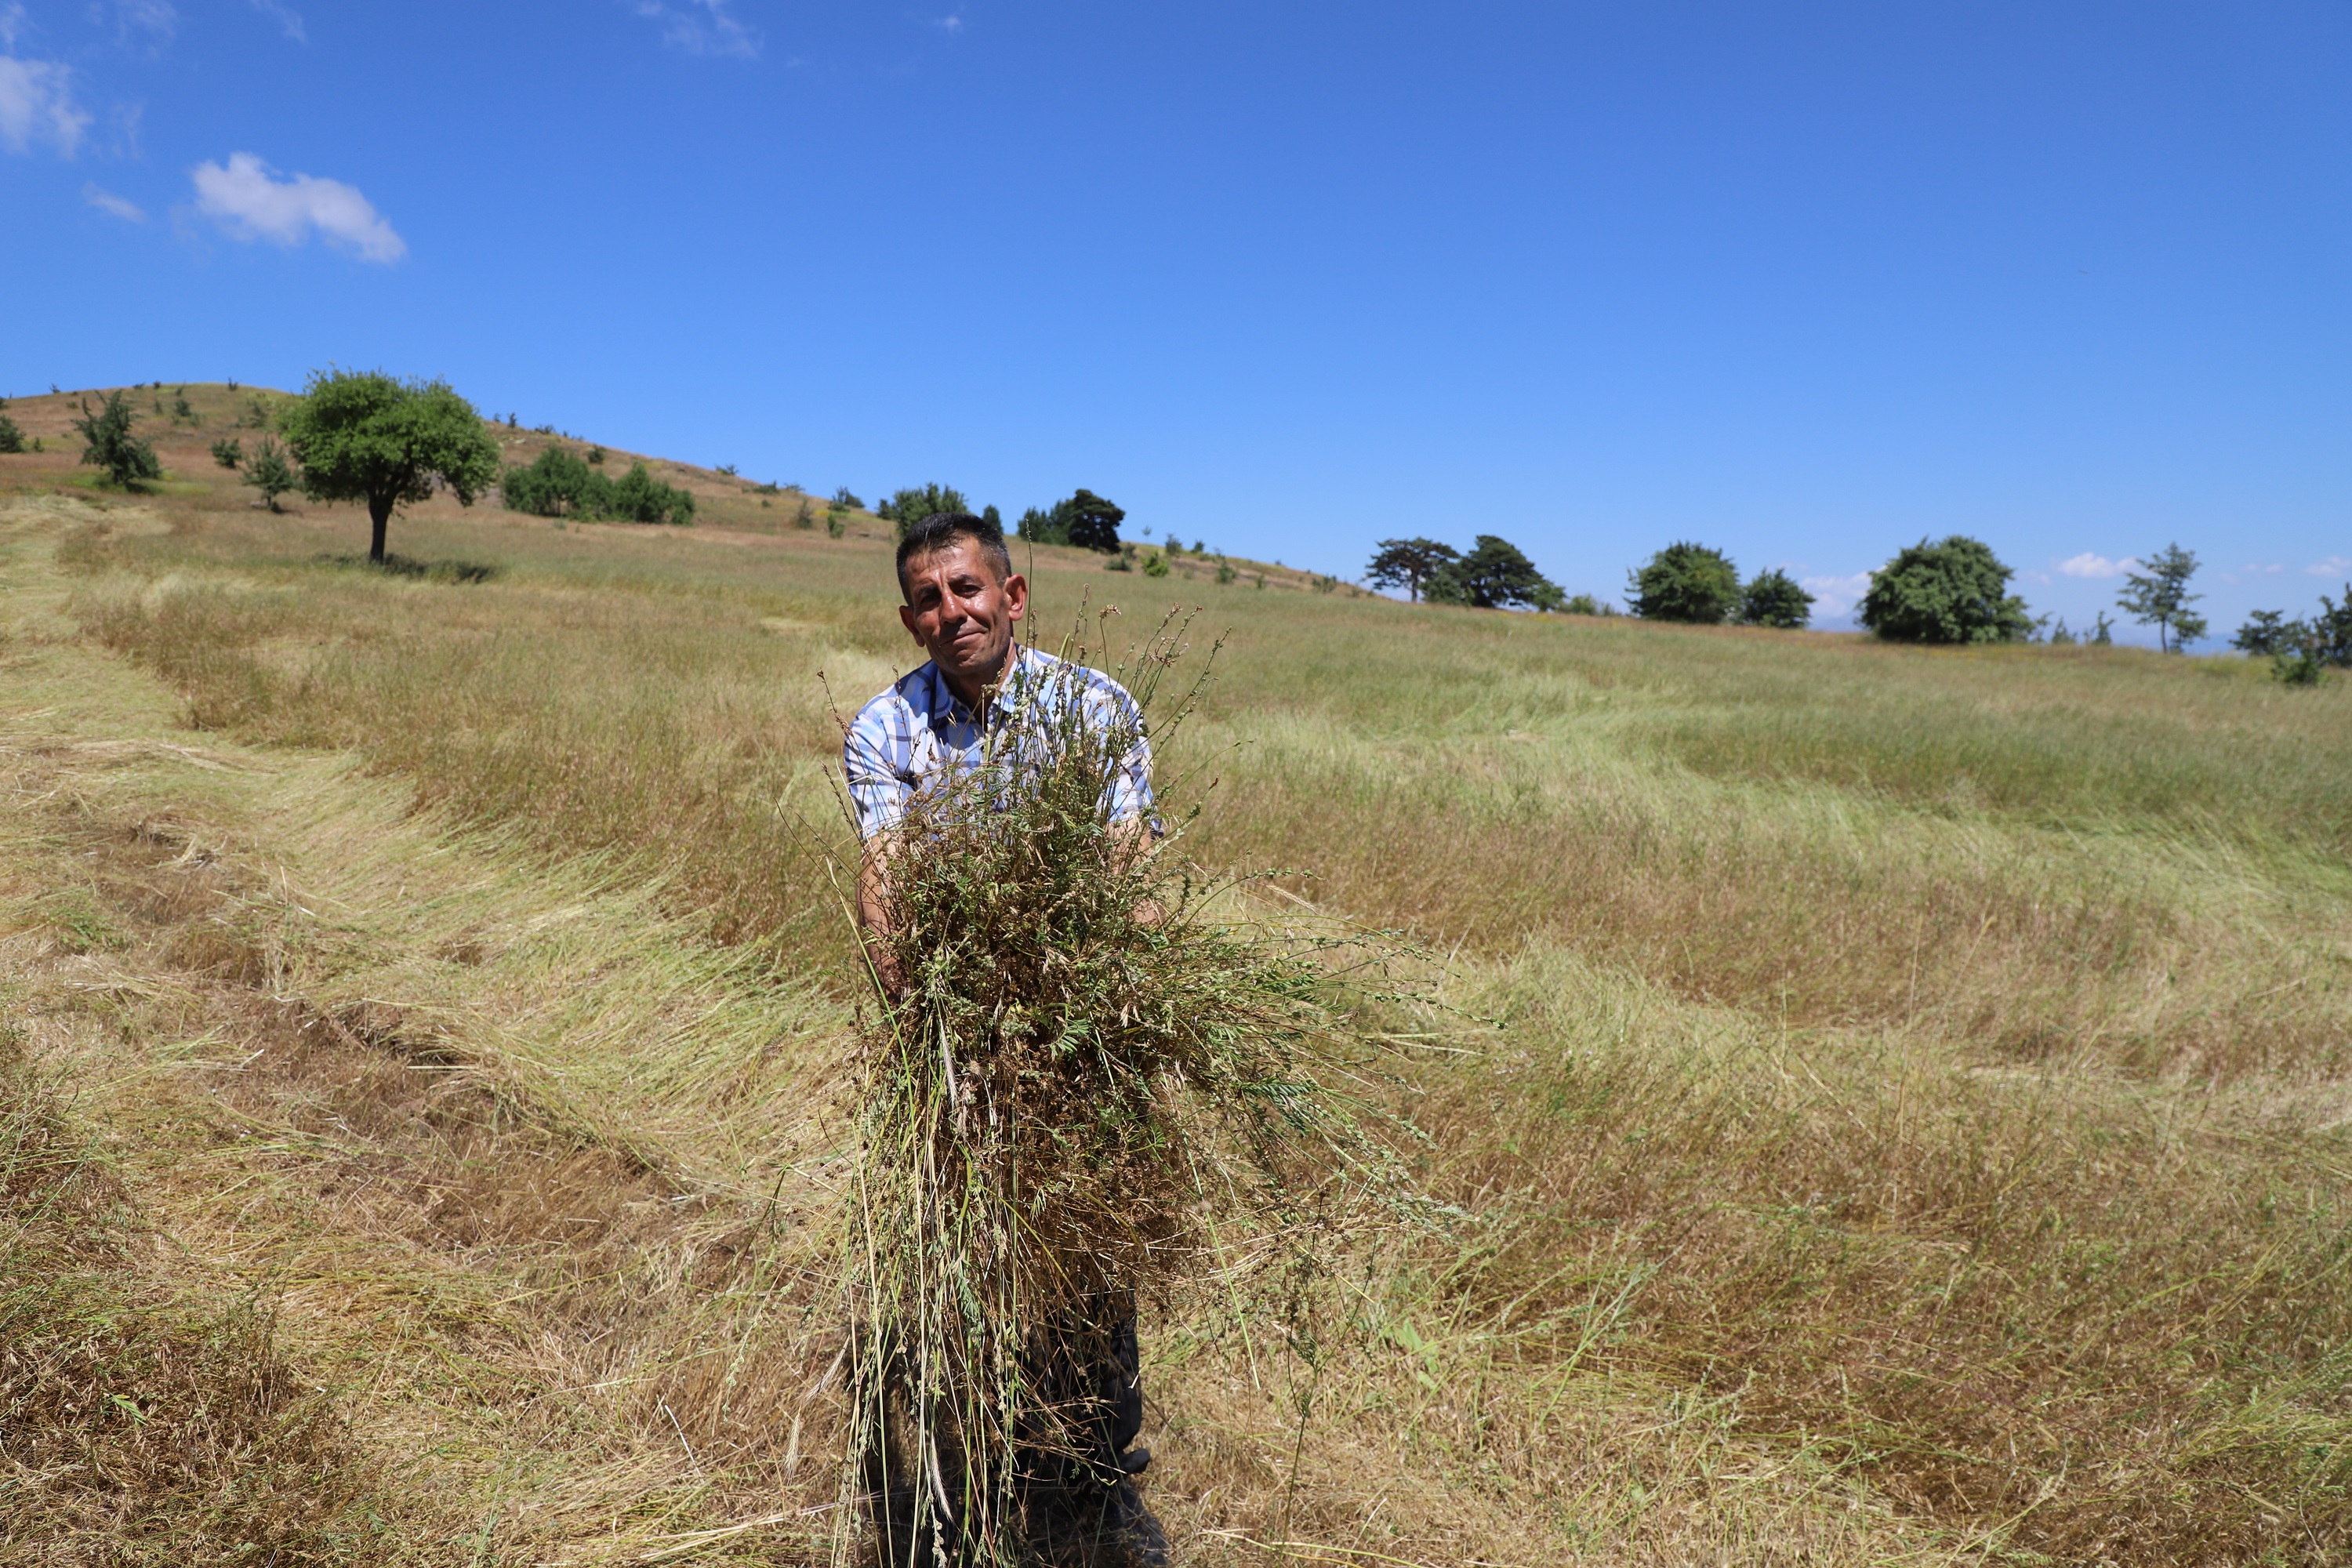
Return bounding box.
[0,388,2352,1566]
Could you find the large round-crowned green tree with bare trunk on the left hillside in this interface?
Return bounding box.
[278,369,499,562]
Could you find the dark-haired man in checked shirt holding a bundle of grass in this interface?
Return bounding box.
[842,513,1167,1568]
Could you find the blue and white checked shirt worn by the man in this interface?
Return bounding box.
[842,644,1152,839]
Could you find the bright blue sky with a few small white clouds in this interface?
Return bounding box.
[0,0,2352,647]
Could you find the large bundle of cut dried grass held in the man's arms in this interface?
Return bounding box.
[842,621,1402,1563]
